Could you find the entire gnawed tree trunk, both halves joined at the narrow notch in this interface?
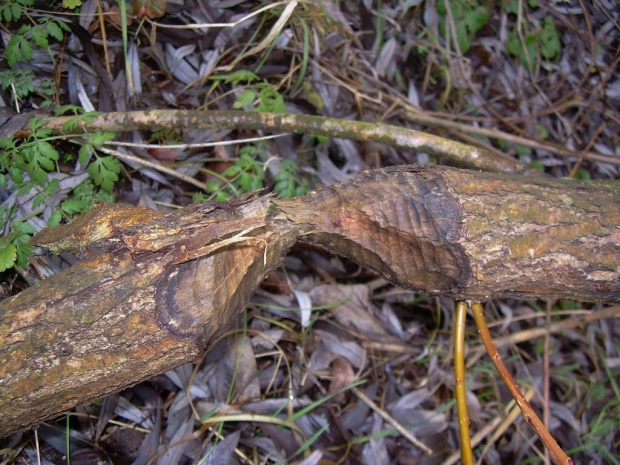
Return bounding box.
[0,166,620,435]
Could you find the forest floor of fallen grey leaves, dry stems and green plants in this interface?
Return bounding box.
[0,0,620,465]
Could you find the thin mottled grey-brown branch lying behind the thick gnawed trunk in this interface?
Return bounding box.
[15,110,541,176]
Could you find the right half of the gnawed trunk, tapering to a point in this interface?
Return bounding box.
[274,166,620,301]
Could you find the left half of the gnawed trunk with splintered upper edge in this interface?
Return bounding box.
[0,192,297,435]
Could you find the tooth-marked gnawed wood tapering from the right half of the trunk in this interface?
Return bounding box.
[275,167,471,294]
